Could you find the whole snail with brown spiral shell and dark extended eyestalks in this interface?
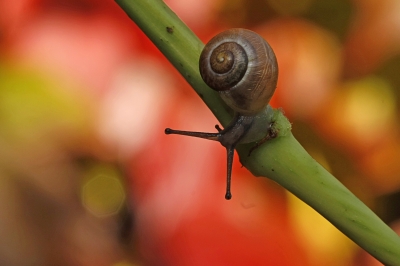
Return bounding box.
[165,29,278,200]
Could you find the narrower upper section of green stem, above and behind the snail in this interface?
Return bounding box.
[116,0,232,125]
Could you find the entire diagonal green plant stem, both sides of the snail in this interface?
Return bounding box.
[116,0,400,265]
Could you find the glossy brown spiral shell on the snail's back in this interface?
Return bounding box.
[200,29,278,115]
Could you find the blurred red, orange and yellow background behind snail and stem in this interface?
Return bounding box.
[0,0,400,266]
